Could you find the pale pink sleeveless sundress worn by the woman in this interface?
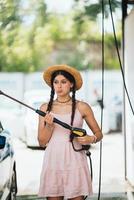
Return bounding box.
[38,109,92,199]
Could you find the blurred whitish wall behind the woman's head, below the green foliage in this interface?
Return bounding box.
[0,70,122,104]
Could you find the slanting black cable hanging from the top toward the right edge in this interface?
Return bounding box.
[109,0,134,115]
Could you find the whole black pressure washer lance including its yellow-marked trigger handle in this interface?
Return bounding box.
[0,90,90,151]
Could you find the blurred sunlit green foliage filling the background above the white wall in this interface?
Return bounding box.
[0,0,121,72]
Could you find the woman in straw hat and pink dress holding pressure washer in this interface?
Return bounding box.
[38,65,103,200]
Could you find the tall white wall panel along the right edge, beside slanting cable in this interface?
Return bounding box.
[125,7,134,186]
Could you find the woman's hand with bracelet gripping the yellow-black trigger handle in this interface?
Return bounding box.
[76,135,97,145]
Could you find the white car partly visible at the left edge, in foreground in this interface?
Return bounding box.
[0,121,17,200]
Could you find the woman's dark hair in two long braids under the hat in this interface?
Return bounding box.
[47,70,76,126]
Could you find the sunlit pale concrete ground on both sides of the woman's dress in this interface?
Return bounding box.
[13,133,133,200]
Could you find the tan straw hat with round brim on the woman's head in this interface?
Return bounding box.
[43,64,83,90]
